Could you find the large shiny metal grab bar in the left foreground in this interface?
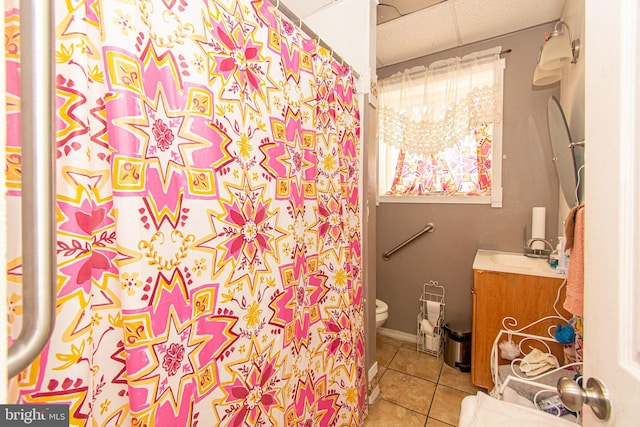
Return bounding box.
[7,0,56,378]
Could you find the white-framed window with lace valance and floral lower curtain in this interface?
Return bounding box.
[378,47,504,207]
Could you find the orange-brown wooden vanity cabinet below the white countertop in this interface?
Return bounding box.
[471,270,572,391]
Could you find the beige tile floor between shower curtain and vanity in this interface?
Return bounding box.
[364,334,486,427]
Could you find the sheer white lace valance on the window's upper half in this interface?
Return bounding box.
[379,46,502,155]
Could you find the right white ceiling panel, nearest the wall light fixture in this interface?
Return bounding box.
[449,0,565,44]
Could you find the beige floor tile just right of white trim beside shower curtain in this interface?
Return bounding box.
[380,369,436,415]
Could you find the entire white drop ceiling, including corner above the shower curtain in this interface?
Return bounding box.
[280,0,567,67]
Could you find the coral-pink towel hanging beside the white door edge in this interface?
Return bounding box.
[563,205,584,317]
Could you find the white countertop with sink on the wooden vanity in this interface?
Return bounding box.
[473,249,565,279]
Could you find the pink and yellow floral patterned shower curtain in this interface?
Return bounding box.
[5,0,366,427]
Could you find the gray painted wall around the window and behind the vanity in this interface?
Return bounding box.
[376,24,559,334]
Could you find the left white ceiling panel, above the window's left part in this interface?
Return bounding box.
[376,2,458,67]
